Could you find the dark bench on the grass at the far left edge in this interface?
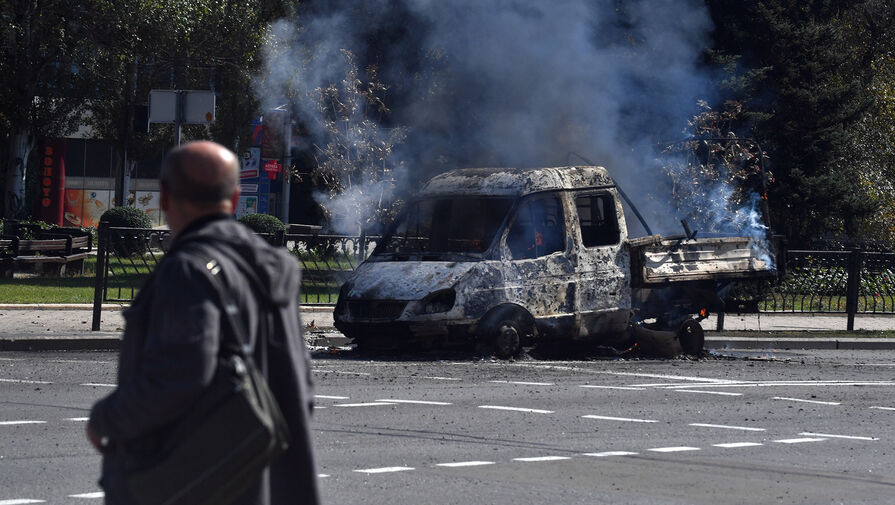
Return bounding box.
[0,228,93,278]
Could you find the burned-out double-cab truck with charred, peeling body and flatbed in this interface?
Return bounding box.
[334,166,774,358]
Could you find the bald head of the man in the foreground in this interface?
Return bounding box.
[161,141,239,235]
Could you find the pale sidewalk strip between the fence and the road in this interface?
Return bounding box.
[0,304,895,351]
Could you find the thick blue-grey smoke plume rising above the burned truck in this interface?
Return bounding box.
[258,0,768,246]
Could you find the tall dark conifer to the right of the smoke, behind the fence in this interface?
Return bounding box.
[708,0,892,244]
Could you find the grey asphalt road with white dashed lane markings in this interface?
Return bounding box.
[0,351,895,505]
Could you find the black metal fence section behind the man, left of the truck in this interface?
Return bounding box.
[92,223,379,331]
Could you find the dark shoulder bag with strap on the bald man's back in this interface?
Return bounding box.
[127,259,289,505]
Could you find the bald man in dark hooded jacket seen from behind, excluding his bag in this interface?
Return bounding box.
[87,142,318,505]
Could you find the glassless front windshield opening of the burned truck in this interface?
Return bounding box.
[371,195,518,261]
